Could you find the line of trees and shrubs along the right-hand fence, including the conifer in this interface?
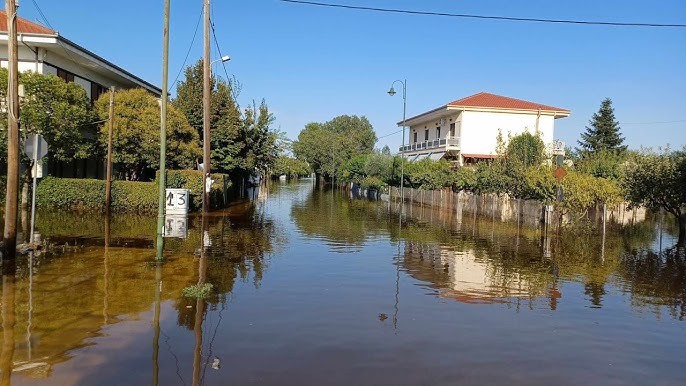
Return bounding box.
[293,98,686,244]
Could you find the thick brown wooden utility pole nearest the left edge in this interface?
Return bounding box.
[3,0,19,259]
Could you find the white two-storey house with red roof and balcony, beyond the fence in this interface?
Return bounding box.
[398,92,570,165]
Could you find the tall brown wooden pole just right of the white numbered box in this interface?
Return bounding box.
[202,0,212,213]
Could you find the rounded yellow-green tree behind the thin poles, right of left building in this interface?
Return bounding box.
[95,88,201,180]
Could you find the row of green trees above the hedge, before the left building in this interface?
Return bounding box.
[0,60,279,187]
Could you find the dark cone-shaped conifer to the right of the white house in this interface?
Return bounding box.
[577,98,626,156]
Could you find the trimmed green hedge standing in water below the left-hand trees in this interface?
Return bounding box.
[36,170,231,213]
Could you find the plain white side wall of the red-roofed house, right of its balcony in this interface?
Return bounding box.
[461,111,555,154]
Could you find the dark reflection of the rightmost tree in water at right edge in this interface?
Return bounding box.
[618,247,686,320]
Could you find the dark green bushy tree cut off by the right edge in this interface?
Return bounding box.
[622,147,686,245]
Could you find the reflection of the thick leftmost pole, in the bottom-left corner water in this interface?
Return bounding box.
[0,260,17,386]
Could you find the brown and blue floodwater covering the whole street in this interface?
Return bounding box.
[0,181,686,385]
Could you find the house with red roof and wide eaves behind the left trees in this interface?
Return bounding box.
[0,11,162,178]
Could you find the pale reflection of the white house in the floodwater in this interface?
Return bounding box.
[403,242,547,303]
